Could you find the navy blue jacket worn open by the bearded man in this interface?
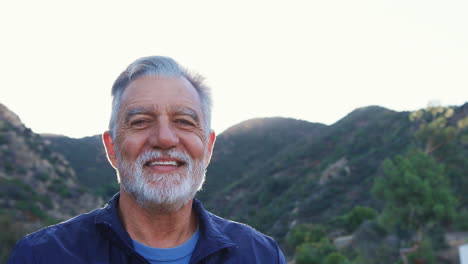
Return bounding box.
[8,194,286,264]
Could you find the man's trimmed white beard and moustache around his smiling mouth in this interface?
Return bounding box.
[117,150,205,212]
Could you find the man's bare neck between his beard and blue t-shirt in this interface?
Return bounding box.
[119,190,197,248]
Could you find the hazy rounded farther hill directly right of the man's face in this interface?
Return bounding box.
[198,118,326,202]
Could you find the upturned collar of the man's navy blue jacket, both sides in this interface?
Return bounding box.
[95,193,237,261]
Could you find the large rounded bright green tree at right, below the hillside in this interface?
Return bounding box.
[372,149,456,263]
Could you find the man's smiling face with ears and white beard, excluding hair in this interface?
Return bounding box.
[104,76,215,210]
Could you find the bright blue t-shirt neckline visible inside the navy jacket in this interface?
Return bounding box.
[133,228,199,264]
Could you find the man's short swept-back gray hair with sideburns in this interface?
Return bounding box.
[109,56,212,141]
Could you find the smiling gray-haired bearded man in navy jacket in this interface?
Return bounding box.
[8,57,285,264]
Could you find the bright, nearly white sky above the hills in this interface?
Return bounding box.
[0,0,468,138]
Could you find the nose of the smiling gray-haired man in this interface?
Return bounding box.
[148,120,179,149]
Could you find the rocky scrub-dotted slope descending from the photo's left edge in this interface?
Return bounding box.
[0,104,103,262]
